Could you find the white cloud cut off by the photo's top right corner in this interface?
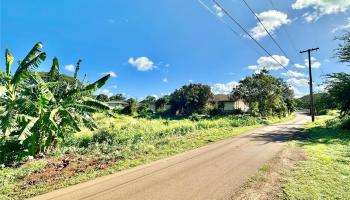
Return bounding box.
[292,0,350,22]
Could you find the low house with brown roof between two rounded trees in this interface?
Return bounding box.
[209,94,249,112]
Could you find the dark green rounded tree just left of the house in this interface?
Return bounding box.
[169,84,213,115]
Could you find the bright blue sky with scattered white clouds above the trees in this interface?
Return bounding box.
[0,0,350,98]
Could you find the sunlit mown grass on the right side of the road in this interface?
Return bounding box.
[281,116,350,199]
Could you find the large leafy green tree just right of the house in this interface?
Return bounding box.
[231,69,295,116]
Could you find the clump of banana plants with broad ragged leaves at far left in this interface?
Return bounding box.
[0,43,109,162]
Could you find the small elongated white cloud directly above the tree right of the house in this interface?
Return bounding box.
[248,55,289,72]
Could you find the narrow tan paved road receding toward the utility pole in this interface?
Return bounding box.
[35,114,309,200]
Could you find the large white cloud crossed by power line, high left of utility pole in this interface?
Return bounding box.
[250,10,291,40]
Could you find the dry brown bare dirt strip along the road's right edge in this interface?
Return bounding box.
[231,147,306,200]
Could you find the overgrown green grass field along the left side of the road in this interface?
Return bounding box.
[0,115,294,199]
